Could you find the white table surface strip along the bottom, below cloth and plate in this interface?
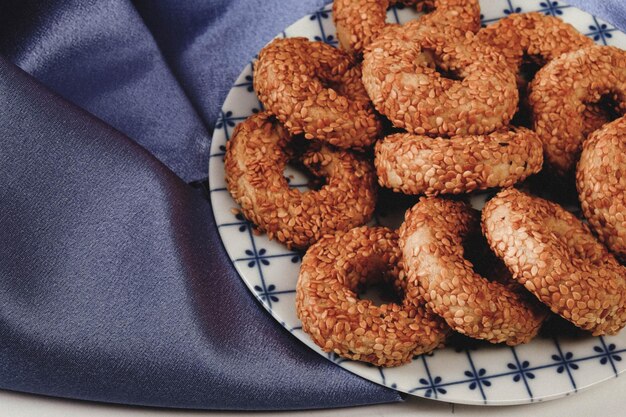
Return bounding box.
[0,374,626,417]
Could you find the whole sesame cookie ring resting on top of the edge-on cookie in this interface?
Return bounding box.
[363,22,518,136]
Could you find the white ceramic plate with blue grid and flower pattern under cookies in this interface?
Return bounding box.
[209,0,626,405]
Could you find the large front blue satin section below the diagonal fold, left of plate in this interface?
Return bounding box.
[0,58,399,410]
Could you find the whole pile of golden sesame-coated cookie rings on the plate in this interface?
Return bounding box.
[225,0,626,366]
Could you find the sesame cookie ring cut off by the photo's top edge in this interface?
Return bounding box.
[333,0,480,55]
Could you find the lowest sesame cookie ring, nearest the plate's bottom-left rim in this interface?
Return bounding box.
[296,227,449,366]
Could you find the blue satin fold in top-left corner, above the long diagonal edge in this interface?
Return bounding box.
[0,0,210,181]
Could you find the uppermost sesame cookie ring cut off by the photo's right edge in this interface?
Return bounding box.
[528,46,626,175]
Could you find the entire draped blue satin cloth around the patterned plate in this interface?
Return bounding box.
[0,0,626,410]
